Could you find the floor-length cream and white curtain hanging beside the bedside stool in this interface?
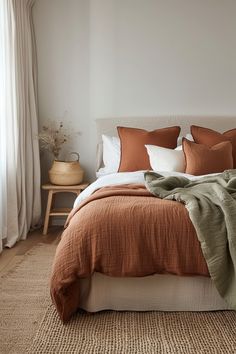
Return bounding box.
[0,0,41,251]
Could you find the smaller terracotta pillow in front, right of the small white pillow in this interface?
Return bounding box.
[183,138,233,176]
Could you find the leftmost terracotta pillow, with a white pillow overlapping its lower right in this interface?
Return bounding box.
[117,126,180,172]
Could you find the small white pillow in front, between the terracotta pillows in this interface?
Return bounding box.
[145,145,185,172]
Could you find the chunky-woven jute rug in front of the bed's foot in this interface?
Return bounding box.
[30,306,236,354]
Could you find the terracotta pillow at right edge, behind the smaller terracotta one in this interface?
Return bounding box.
[191,125,236,168]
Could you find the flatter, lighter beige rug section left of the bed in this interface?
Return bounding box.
[0,244,56,354]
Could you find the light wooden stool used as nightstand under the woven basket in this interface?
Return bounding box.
[42,183,89,235]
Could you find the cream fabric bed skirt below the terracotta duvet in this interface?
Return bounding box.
[80,273,228,312]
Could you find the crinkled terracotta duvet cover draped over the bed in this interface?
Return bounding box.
[51,173,209,322]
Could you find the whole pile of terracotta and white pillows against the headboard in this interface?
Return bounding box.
[99,125,236,175]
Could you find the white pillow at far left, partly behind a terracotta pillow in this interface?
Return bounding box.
[102,135,120,173]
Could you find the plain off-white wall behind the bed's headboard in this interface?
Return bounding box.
[34,0,236,209]
